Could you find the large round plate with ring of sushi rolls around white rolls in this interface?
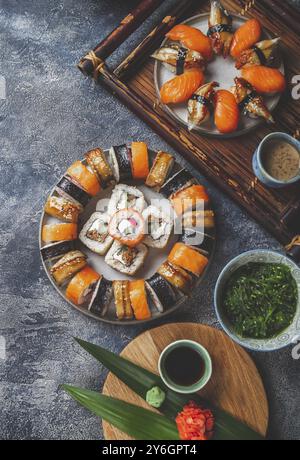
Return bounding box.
[39,142,215,325]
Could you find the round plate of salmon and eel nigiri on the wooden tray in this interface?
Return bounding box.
[152,0,286,137]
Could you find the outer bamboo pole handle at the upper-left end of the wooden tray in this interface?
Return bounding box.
[78,0,164,76]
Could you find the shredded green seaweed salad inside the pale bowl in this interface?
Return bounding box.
[223,262,298,339]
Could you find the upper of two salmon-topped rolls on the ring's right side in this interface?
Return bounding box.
[170,184,209,215]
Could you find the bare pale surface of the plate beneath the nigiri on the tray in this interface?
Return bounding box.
[154,13,284,138]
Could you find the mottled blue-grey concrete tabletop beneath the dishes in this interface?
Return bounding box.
[0,0,300,439]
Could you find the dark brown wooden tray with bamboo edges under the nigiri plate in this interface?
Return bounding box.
[79,0,300,252]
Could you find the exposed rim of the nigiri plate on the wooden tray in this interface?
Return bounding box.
[153,13,285,139]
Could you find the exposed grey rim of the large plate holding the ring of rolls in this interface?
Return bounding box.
[39,153,217,326]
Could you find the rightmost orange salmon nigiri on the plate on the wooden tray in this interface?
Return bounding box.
[242,65,286,93]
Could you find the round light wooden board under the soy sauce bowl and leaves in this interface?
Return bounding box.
[103,323,269,440]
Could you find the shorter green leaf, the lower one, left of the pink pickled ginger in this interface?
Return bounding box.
[62,385,179,441]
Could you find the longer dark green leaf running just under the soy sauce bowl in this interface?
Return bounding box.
[75,338,264,440]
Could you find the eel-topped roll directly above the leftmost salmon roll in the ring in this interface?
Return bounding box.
[45,196,82,223]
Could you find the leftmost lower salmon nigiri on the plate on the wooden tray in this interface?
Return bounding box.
[160,69,204,104]
